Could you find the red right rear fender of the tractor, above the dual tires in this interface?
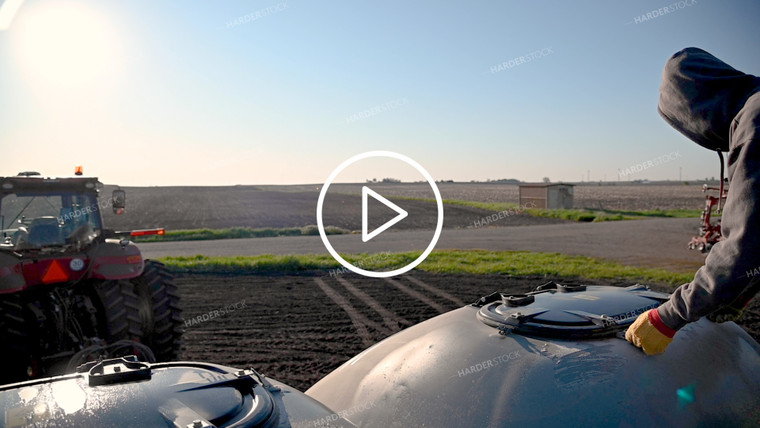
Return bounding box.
[88,239,145,279]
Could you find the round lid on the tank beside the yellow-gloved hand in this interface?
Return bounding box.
[473,282,670,339]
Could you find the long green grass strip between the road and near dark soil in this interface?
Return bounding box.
[160,250,693,285]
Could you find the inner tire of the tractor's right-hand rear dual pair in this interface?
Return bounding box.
[93,281,141,343]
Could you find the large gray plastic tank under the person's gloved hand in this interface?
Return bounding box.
[306,283,760,428]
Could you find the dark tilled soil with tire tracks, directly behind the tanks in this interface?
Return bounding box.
[177,272,760,390]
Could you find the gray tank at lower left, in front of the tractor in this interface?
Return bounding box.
[0,358,354,428]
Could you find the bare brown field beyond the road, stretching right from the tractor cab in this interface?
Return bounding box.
[103,186,563,230]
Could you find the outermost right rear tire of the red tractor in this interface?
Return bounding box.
[132,260,184,361]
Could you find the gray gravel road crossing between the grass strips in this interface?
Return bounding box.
[140,218,704,272]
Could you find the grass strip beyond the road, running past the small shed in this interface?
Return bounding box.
[397,197,702,222]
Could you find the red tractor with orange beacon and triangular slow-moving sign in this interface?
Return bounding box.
[0,171,183,383]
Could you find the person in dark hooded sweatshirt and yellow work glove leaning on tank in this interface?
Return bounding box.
[625,48,760,355]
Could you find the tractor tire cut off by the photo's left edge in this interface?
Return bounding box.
[0,294,32,384]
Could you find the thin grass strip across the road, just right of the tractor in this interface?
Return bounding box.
[135,225,351,242]
